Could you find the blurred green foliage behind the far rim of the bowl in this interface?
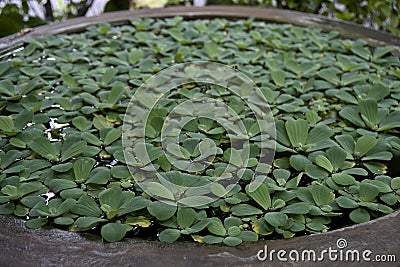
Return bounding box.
[0,0,400,36]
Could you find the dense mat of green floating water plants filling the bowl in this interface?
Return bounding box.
[0,17,400,246]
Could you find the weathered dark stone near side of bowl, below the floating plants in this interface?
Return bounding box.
[0,211,400,267]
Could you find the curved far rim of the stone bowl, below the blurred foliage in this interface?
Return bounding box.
[0,5,400,54]
